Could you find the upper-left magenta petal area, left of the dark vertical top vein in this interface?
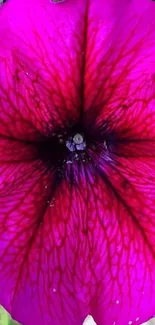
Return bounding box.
[0,0,85,140]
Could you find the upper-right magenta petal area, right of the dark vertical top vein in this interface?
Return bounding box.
[85,0,155,140]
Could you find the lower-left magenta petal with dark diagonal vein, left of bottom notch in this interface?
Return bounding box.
[0,162,91,324]
